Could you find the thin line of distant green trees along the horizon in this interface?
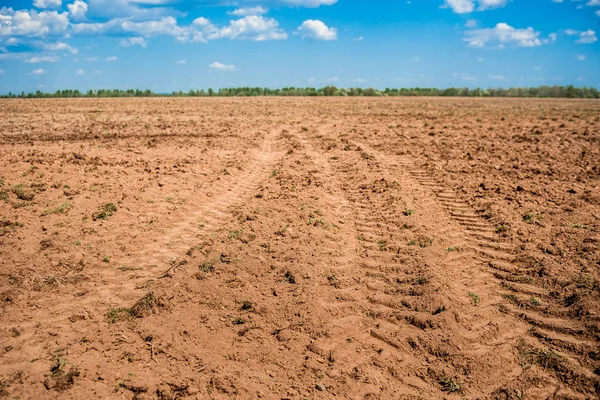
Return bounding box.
[0,85,600,99]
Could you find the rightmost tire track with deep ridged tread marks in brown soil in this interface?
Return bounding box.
[363,145,600,394]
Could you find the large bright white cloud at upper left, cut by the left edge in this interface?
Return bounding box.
[0,7,69,37]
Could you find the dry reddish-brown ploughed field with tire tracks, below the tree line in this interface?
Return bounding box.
[0,98,600,399]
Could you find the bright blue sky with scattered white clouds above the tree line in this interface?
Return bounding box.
[0,0,600,93]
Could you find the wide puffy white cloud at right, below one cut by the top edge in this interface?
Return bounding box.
[463,22,545,47]
